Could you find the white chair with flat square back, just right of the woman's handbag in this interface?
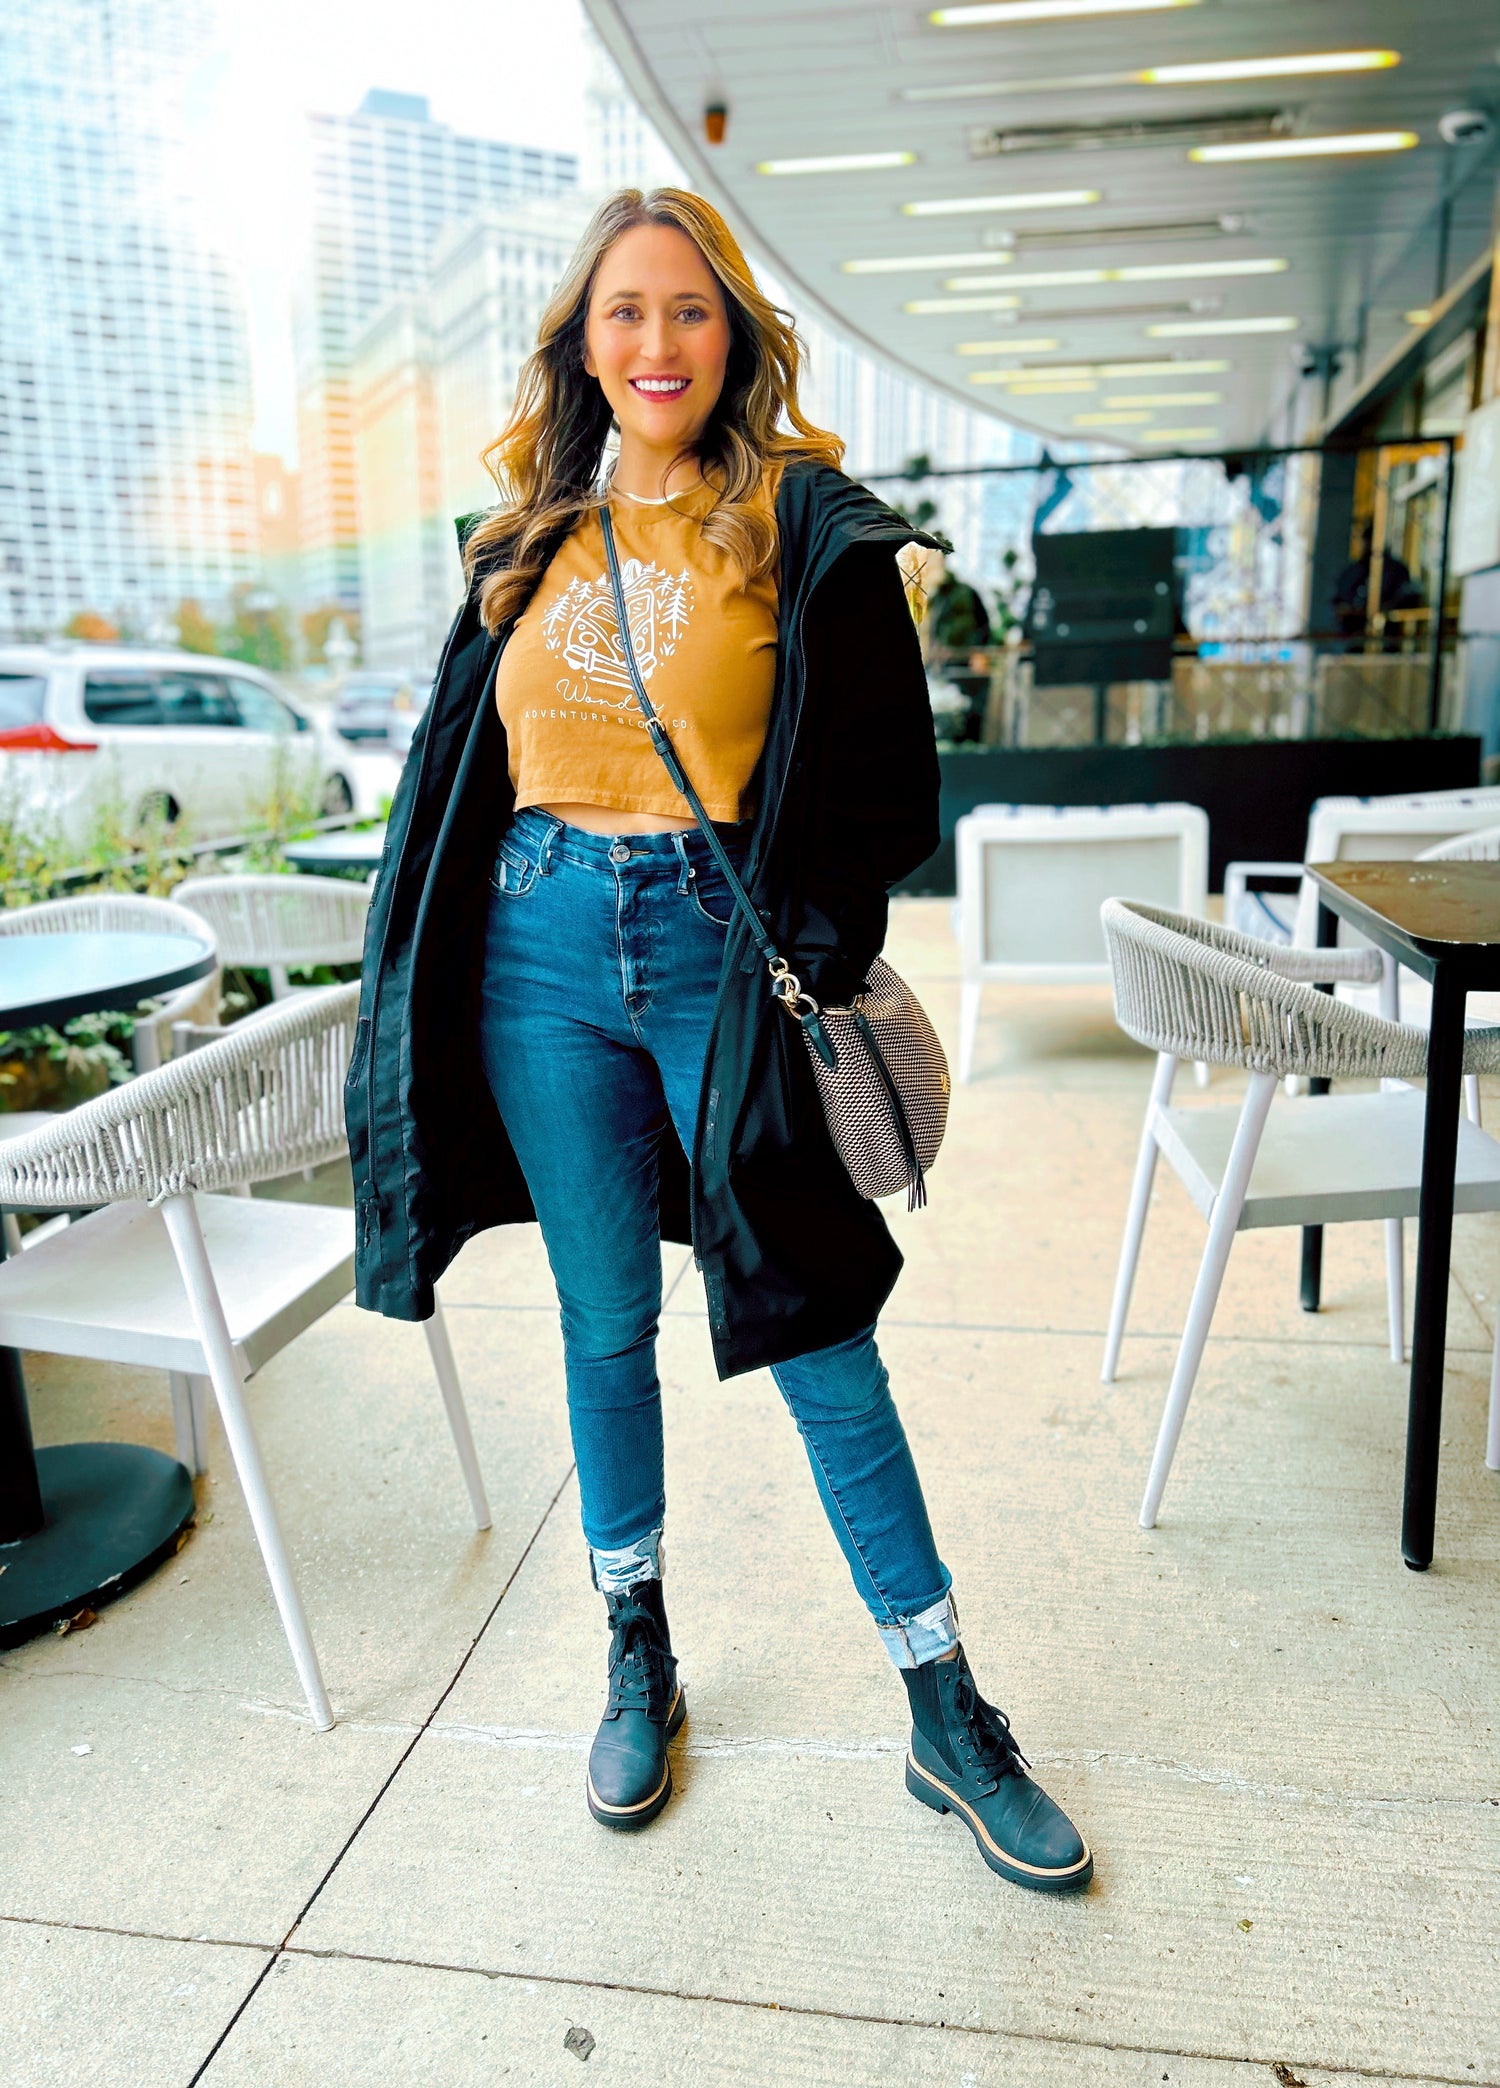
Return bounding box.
[953,804,1208,1082]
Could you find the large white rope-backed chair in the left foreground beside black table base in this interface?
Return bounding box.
[0,986,491,1729]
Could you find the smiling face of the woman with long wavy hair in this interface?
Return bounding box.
[583,226,729,470]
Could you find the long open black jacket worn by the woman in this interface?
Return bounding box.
[347,464,938,1378]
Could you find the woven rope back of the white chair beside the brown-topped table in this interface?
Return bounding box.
[1099,900,1427,1079]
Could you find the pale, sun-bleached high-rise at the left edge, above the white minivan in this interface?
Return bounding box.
[0,0,255,637]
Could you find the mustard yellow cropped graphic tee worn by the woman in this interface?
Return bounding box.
[495,487,777,821]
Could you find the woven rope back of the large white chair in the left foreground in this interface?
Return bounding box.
[0,983,359,1209]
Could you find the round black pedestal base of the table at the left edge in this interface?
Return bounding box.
[0,1443,192,1647]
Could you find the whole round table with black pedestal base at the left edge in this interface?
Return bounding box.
[0,933,217,1647]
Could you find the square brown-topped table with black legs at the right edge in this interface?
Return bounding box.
[1308,862,1500,1572]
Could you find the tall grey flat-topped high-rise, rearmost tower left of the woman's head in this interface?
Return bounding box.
[295,90,579,614]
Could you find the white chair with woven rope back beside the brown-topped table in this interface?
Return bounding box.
[1101,900,1500,1531]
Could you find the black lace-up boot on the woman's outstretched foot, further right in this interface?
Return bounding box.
[900,1647,1095,1892]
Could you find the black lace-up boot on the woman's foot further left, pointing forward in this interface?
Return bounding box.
[589,1581,687,1827]
